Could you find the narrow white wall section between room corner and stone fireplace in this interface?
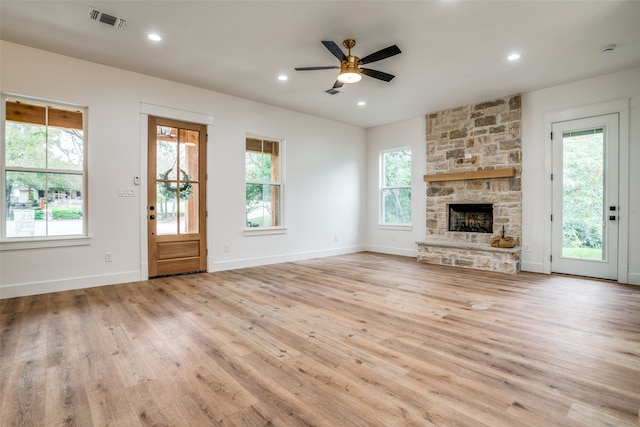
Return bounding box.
[366,116,427,256]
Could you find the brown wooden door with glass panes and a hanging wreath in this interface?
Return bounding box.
[147,117,207,277]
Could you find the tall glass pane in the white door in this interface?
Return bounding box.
[562,128,605,260]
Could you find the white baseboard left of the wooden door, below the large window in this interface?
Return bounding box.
[0,271,140,299]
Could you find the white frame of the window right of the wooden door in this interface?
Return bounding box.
[244,133,286,236]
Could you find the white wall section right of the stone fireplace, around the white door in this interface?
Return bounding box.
[522,68,640,284]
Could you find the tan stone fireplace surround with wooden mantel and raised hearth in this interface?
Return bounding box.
[417,95,522,273]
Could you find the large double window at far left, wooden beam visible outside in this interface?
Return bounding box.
[0,95,87,240]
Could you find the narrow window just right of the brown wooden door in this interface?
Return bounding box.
[245,136,282,229]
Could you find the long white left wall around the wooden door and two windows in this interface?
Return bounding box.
[0,42,367,298]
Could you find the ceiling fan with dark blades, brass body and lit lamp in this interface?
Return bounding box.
[295,39,401,95]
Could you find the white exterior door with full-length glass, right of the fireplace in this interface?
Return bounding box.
[551,114,619,280]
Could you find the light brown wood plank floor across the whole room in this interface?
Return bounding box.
[0,253,640,427]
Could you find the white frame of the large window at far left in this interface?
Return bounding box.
[0,92,91,251]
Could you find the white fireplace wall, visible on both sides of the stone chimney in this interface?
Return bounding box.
[366,68,640,284]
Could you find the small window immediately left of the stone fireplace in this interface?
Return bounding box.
[380,148,411,225]
